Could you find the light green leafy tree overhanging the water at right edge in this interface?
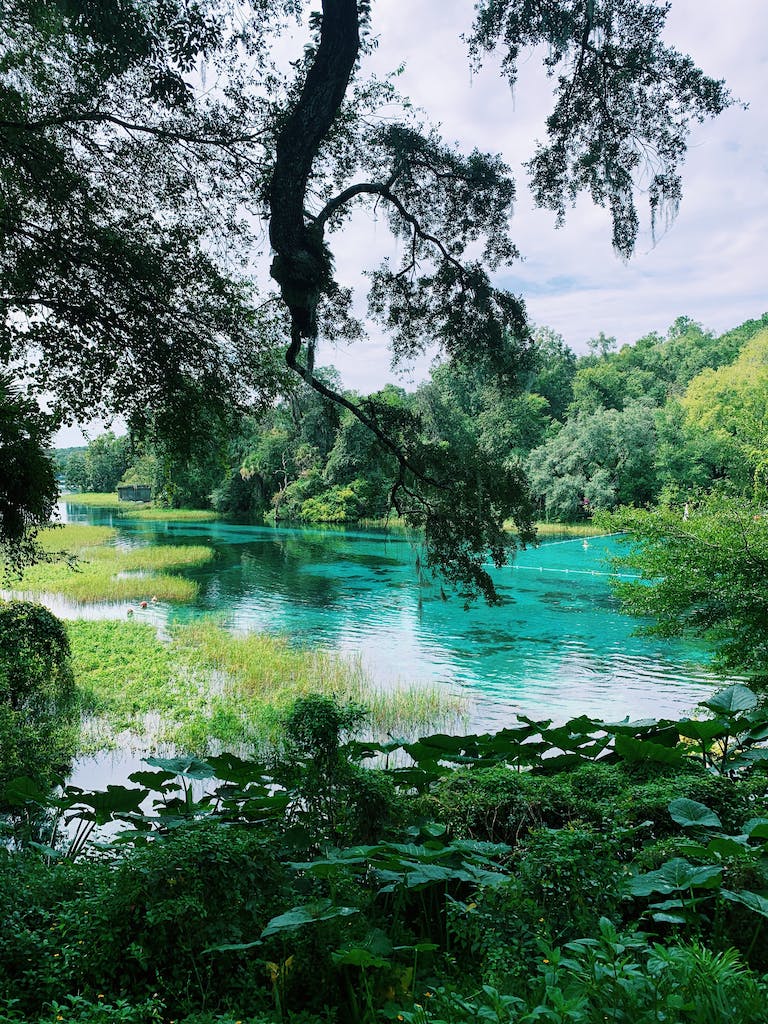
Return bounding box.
[604,494,768,683]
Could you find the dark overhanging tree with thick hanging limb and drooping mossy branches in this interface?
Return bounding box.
[0,0,729,599]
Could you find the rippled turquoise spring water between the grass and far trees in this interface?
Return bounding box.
[57,506,721,728]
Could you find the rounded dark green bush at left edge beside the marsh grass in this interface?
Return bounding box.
[0,601,78,808]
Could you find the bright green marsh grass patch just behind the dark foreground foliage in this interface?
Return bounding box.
[67,621,466,756]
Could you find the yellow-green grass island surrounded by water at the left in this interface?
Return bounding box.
[9,523,214,602]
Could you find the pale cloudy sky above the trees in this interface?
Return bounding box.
[56,0,768,446]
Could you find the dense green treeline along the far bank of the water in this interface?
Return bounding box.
[59,313,768,522]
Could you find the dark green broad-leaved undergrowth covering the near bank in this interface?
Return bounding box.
[0,687,768,1024]
